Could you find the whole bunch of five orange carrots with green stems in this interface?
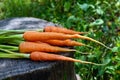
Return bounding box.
[0,26,110,65]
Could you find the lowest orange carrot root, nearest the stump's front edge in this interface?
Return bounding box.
[30,52,101,65]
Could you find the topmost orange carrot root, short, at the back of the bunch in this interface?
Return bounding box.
[44,26,87,34]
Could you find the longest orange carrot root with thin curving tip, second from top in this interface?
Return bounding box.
[23,31,111,50]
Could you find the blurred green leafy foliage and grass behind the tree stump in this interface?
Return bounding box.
[0,0,120,80]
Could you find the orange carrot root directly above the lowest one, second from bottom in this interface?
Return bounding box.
[19,42,76,53]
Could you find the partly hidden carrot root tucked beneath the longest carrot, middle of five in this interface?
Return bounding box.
[43,39,85,46]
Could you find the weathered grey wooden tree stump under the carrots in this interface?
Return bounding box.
[0,17,76,80]
